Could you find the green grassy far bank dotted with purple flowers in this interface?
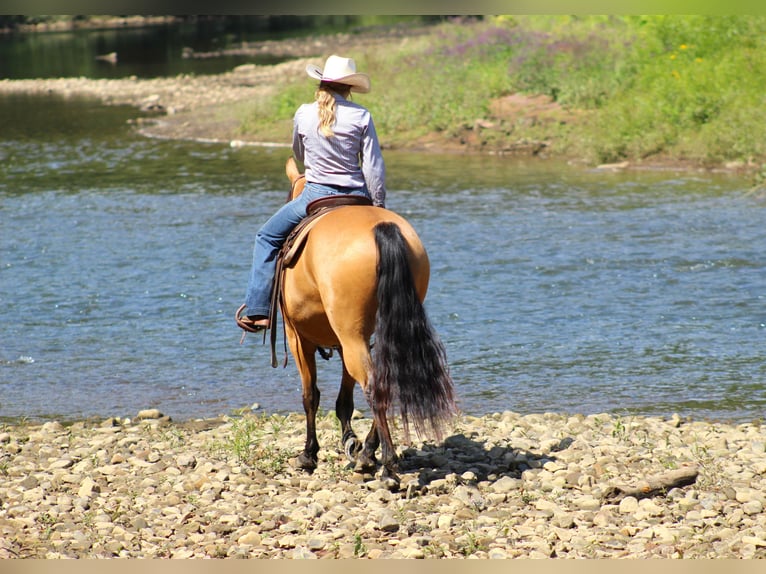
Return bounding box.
[242,15,766,167]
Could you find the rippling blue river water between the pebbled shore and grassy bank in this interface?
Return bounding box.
[0,94,766,426]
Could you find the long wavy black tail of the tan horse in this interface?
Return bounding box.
[370,223,457,439]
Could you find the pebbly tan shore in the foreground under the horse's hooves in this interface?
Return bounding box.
[0,411,766,558]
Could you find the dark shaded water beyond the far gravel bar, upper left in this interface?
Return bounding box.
[0,15,420,79]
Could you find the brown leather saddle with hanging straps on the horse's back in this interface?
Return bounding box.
[269,195,372,368]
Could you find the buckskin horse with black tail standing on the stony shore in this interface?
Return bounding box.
[252,158,457,480]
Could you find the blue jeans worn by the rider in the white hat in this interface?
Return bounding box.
[245,183,370,316]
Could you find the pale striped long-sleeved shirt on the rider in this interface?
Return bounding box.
[293,93,386,207]
